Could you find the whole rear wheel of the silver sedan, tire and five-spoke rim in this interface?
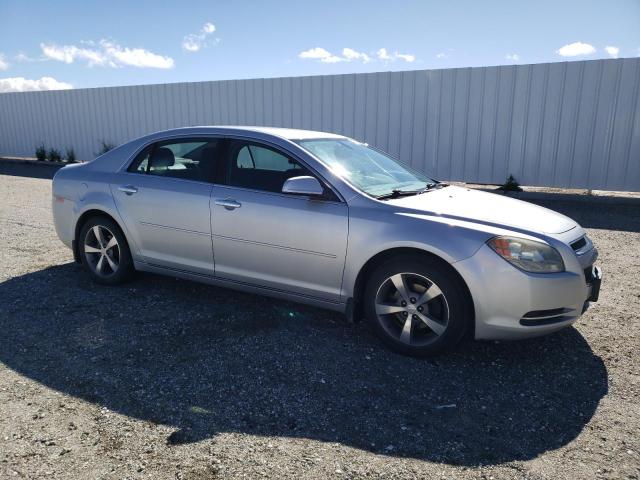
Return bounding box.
[77,217,134,285]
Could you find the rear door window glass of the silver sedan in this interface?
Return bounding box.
[129,139,220,182]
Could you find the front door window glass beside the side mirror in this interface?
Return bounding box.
[228,141,310,193]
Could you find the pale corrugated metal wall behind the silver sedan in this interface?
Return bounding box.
[0,58,640,190]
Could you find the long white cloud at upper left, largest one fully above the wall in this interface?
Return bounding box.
[40,40,174,68]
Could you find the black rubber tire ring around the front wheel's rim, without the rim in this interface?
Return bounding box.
[364,256,470,357]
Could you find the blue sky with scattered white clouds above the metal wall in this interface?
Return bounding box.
[0,0,640,92]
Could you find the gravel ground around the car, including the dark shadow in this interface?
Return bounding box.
[0,167,640,479]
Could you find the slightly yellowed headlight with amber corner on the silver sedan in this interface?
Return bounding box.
[487,237,564,273]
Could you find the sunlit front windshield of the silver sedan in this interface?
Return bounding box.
[298,138,435,197]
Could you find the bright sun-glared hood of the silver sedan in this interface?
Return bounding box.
[388,185,577,234]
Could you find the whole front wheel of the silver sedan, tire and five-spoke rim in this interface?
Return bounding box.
[364,255,473,357]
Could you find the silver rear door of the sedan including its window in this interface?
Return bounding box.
[111,138,221,276]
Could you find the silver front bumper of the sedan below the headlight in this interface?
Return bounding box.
[454,245,602,340]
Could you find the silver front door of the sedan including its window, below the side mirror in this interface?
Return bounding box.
[211,140,348,302]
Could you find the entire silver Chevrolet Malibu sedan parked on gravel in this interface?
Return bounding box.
[52,127,601,356]
